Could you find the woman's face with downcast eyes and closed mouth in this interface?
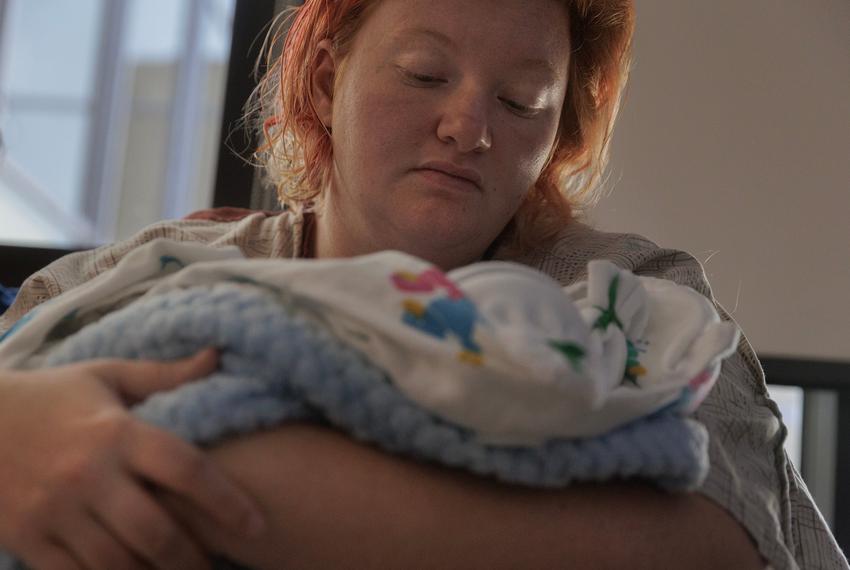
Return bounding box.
[317,0,570,267]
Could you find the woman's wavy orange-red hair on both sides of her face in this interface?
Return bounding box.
[245,0,634,248]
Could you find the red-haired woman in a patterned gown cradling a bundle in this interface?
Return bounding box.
[0,0,842,568]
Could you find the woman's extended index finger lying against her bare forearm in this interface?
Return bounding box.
[128,424,265,537]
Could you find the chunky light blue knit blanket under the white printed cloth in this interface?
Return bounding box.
[0,283,708,569]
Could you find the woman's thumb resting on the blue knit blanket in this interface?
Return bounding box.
[95,348,218,404]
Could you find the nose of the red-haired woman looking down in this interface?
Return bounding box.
[437,89,493,153]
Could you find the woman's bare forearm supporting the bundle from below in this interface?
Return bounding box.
[164,425,764,569]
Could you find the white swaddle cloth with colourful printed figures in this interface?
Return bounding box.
[0,240,738,444]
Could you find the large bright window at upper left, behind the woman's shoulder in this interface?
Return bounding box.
[0,0,236,247]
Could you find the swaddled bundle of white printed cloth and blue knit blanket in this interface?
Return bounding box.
[0,235,738,506]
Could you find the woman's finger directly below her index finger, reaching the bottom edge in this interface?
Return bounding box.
[93,476,210,570]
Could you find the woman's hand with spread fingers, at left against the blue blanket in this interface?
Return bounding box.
[0,350,263,570]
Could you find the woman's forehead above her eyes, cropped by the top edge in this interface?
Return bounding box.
[354,0,570,67]
